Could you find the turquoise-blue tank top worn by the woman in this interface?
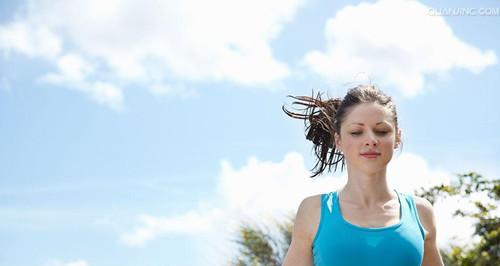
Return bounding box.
[312,190,425,266]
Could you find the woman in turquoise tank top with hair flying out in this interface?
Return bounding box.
[283,85,443,266]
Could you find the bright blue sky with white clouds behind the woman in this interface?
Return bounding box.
[0,0,500,266]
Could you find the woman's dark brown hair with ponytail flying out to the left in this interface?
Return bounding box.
[282,85,398,178]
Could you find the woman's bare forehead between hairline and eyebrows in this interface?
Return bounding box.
[343,103,394,126]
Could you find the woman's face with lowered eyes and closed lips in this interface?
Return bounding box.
[335,103,401,173]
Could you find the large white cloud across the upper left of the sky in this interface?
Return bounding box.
[0,0,304,108]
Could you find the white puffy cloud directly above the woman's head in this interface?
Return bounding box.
[303,0,497,97]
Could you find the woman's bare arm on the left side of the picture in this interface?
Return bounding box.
[283,197,315,266]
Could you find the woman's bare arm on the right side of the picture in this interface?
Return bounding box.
[415,197,444,266]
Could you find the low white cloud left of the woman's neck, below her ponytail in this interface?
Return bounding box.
[122,153,324,245]
